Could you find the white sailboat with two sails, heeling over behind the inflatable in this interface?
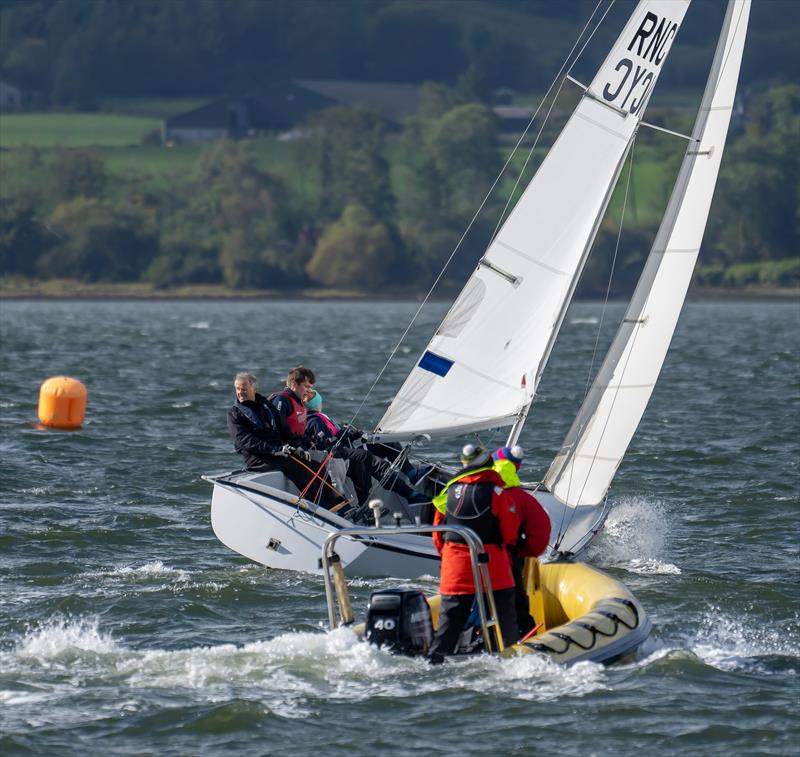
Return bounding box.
[206,0,750,578]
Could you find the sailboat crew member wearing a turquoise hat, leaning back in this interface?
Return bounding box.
[305,389,430,505]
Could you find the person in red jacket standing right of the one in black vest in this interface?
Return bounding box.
[492,445,550,638]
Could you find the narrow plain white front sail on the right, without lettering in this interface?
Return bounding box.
[545,0,750,506]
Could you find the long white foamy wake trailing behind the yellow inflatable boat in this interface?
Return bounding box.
[0,618,609,718]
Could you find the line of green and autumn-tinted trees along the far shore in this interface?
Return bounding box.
[0,78,800,295]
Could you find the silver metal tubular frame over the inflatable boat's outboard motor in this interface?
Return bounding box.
[320,525,505,652]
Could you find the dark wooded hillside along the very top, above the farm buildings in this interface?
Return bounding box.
[0,0,800,108]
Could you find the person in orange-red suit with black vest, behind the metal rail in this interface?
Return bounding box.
[428,444,519,662]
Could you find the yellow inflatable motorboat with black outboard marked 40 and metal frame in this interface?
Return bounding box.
[321,526,652,664]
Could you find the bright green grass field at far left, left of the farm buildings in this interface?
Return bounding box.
[0,113,162,150]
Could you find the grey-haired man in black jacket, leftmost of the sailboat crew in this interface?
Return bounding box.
[227,373,342,508]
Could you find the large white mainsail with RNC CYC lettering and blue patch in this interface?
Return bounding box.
[377,0,689,439]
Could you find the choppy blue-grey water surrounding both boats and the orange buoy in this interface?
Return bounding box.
[0,302,800,756]
